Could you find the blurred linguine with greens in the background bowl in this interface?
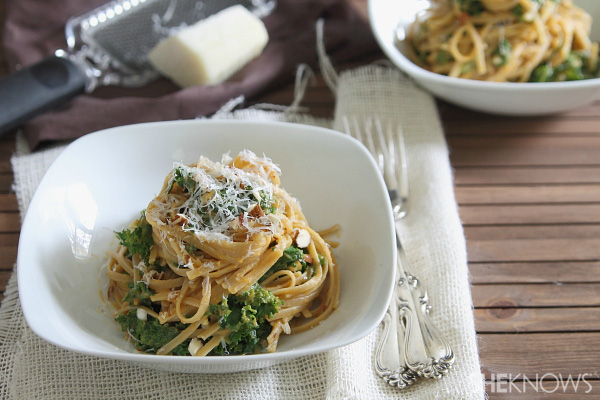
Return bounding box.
[407,0,600,82]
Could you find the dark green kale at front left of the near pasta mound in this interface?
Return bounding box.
[115,310,189,356]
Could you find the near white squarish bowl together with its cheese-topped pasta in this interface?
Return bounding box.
[17,121,396,373]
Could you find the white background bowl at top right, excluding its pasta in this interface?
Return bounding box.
[369,0,600,116]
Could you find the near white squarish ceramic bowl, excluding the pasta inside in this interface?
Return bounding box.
[17,121,396,373]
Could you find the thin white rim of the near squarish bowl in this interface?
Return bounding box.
[17,120,396,372]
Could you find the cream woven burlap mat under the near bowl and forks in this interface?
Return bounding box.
[0,65,484,400]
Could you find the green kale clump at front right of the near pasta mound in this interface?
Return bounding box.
[209,284,282,355]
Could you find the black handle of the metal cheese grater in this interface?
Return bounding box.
[0,56,86,134]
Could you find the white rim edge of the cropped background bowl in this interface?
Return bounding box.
[368,0,600,90]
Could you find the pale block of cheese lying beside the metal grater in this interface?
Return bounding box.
[148,5,269,87]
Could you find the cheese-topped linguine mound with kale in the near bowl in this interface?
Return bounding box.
[107,151,339,356]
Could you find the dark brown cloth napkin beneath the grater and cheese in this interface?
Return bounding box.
[3,0,377,150]
